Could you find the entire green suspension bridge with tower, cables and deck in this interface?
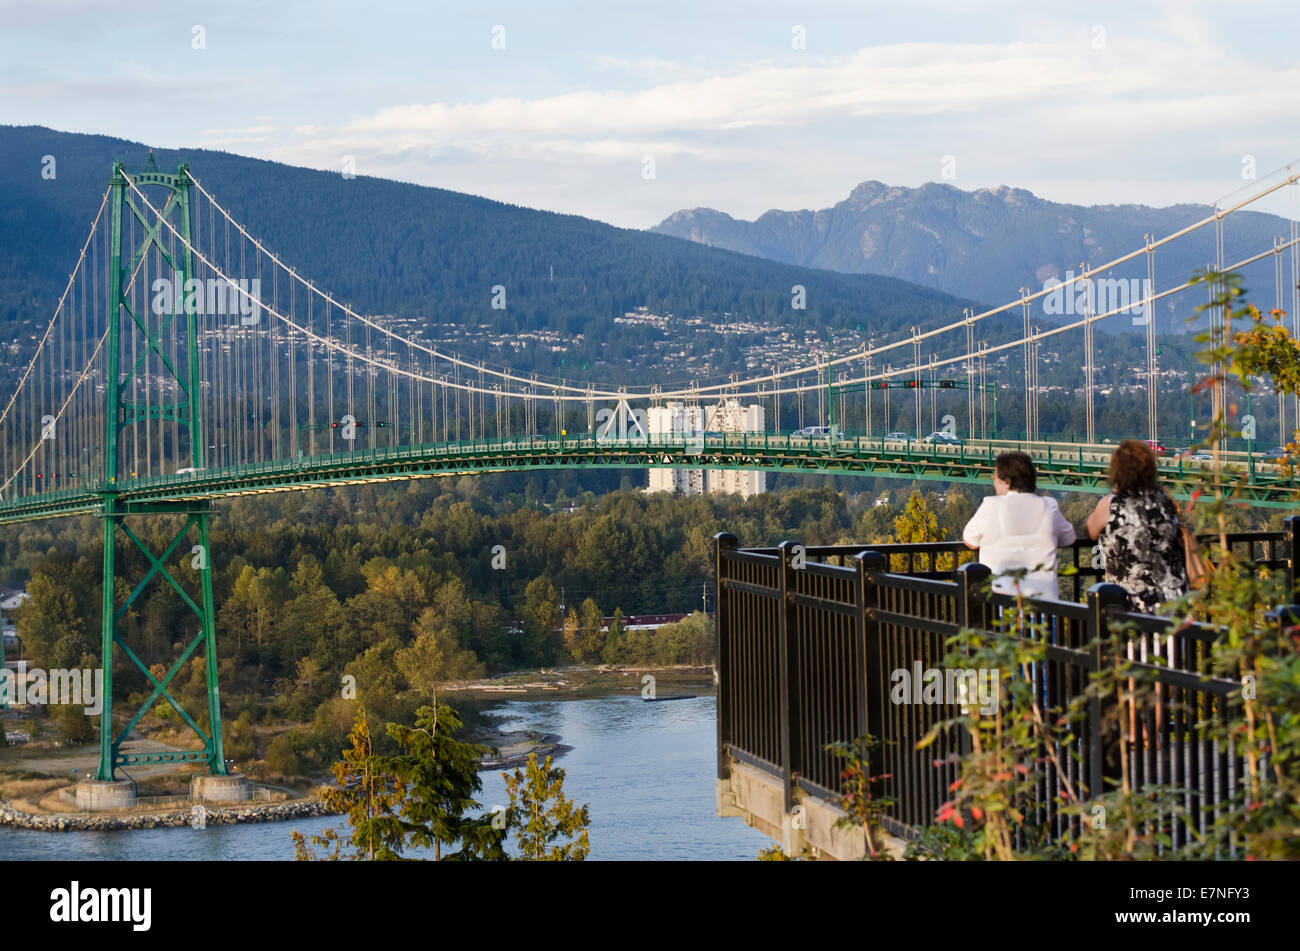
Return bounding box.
[0,155,1300,804]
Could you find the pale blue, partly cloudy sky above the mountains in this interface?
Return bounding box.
[0,0,1300,227]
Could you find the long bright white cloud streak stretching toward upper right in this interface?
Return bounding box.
[317,30,1295,153]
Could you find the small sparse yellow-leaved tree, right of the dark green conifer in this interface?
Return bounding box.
[502,754,590,861]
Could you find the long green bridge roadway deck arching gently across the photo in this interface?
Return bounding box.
[0,434,1300,524]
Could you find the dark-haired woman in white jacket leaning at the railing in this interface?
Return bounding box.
[962,452,1075,600]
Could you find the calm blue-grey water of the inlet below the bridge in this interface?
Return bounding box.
[0,695,771,861]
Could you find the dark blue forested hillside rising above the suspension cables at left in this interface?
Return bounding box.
[0,126,963,372]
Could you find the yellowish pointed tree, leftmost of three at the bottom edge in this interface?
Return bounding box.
[293,707,406,861]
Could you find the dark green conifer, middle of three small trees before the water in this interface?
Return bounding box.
[387,704,508,861]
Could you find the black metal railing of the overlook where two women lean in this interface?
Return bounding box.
[715,516,1300,846]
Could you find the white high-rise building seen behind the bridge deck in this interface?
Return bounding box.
[646,400,767,499]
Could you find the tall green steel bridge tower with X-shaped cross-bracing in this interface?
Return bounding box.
[91,152,226,808]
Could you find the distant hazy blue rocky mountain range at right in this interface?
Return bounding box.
[651,182,1290,310]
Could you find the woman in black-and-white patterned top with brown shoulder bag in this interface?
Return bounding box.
[1088,439,1187,615]
